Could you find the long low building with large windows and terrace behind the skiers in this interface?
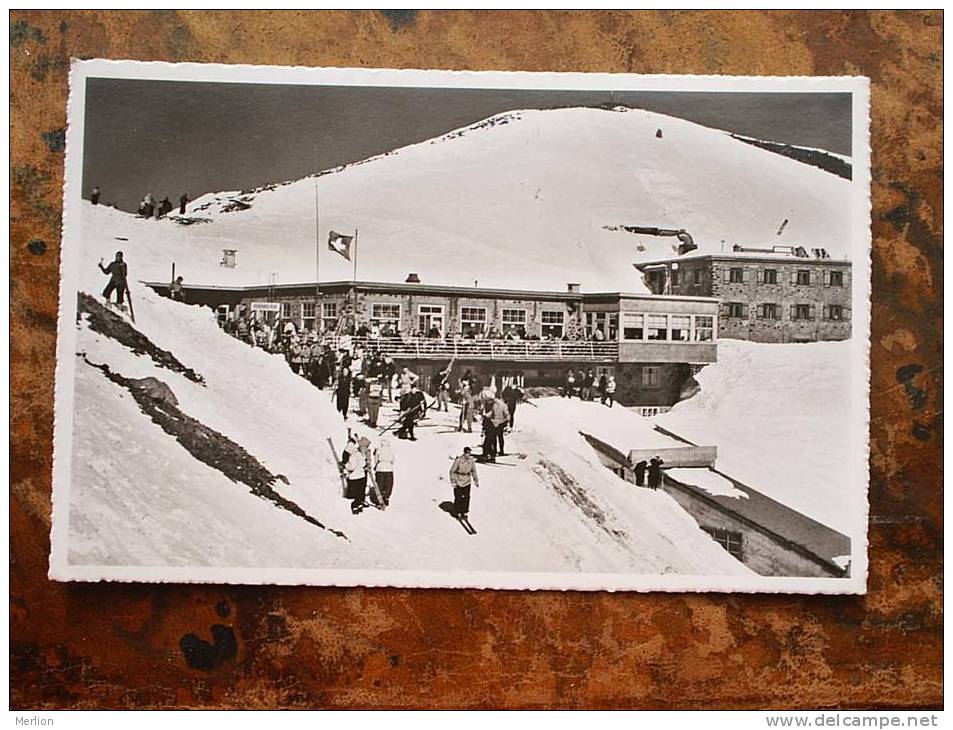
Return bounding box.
[148,277,719,415]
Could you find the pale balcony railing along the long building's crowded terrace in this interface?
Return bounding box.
[334,336,619,362]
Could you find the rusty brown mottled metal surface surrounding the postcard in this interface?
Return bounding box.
[10,11,943,708]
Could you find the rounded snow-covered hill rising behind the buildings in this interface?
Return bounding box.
[81,108,850,291]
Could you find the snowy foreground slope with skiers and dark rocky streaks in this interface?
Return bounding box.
[63,230,748,575]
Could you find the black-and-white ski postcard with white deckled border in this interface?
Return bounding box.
[50,60,870,593]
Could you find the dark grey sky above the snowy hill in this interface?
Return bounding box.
[83,78,851,210]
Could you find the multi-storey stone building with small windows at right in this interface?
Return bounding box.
[635,249,852,342]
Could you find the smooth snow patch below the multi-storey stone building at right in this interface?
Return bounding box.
[654,340,860,535]
